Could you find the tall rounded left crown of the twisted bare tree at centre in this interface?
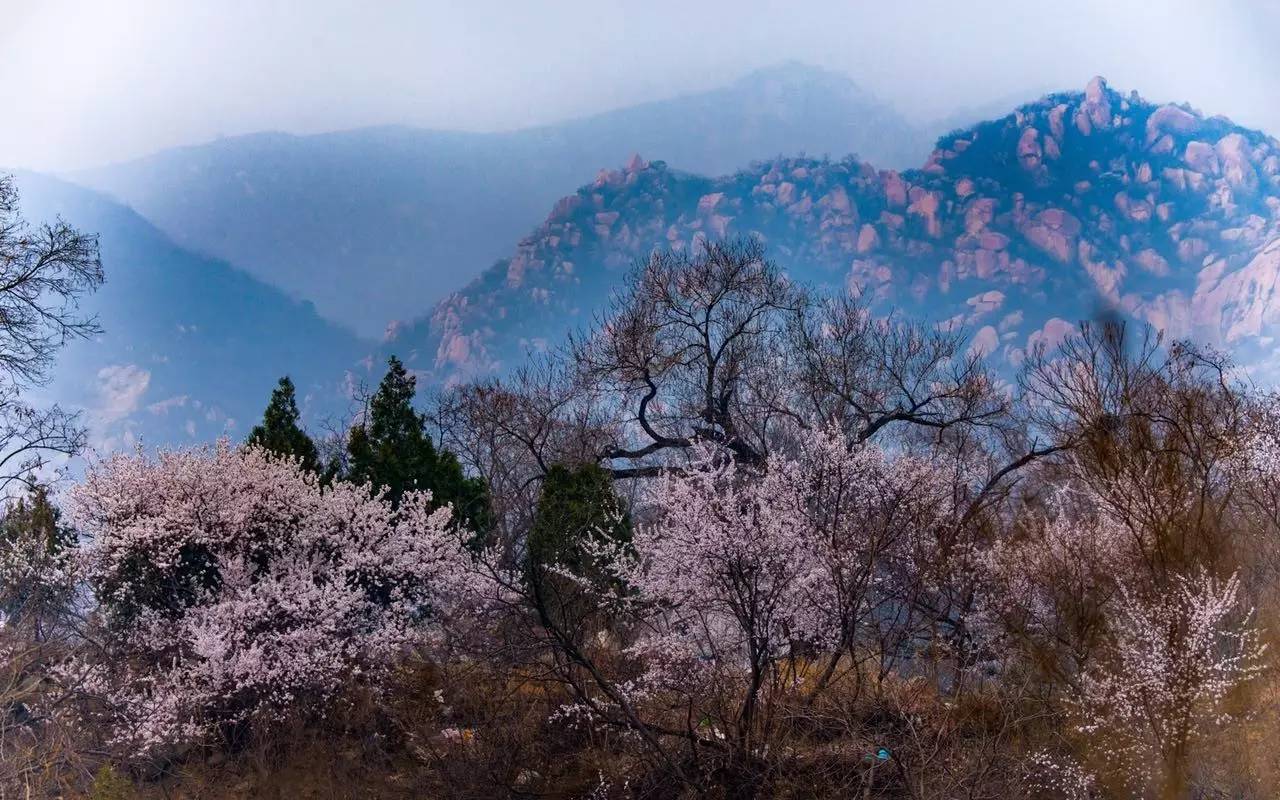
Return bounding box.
[571,239,808,477]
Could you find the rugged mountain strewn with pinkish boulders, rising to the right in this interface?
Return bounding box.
[387,78,1280,381]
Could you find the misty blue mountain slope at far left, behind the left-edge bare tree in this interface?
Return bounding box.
[15,173,369,449]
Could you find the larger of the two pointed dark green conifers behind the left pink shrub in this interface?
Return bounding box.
[347,356,489,534]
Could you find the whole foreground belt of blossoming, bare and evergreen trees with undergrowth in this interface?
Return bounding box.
[0,180,1280,800]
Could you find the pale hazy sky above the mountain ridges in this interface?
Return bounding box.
[0,0,1280,170]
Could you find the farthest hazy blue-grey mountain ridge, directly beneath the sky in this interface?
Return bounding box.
[70,64,929,337]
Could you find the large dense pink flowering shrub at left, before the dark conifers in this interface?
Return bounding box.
[72,443,470,750]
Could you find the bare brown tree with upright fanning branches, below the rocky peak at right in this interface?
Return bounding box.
[1023,321,1253,585]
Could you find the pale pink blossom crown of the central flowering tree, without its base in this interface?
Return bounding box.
[604,429,954,716]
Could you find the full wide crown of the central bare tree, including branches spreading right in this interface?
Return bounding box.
[571,239,1007,477]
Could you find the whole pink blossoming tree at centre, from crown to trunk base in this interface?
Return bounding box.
[540,428,954,756]
